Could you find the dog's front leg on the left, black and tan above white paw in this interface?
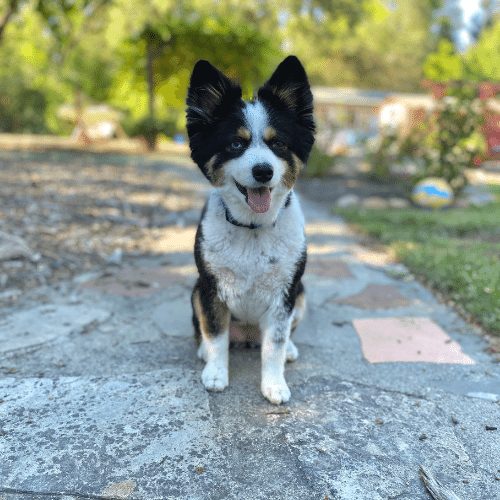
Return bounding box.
[192,277,230,391]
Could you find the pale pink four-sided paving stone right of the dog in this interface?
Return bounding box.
[353,317,474,364]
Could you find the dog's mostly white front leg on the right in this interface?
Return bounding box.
[261,308,292,404]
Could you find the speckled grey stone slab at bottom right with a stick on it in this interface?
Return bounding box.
[281,376,500,500]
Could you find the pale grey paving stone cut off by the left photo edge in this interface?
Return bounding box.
[0,304,110,353]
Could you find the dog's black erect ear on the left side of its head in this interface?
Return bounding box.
[186,60,241,133]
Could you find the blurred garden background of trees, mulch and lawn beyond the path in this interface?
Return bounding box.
[0,0,500,336]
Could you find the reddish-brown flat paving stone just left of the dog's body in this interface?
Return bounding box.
[83,267,186,297]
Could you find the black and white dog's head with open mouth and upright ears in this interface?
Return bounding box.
[187,56,314,222]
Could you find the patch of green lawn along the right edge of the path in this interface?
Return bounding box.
[336,186,500,335]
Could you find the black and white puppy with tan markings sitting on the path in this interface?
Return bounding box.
[187,56,314,404]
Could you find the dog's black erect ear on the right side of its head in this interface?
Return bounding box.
[258,56,314,130]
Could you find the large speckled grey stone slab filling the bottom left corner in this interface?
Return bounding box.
[0,368,221,498]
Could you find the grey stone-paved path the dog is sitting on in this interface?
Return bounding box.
[0,157,500,500]
